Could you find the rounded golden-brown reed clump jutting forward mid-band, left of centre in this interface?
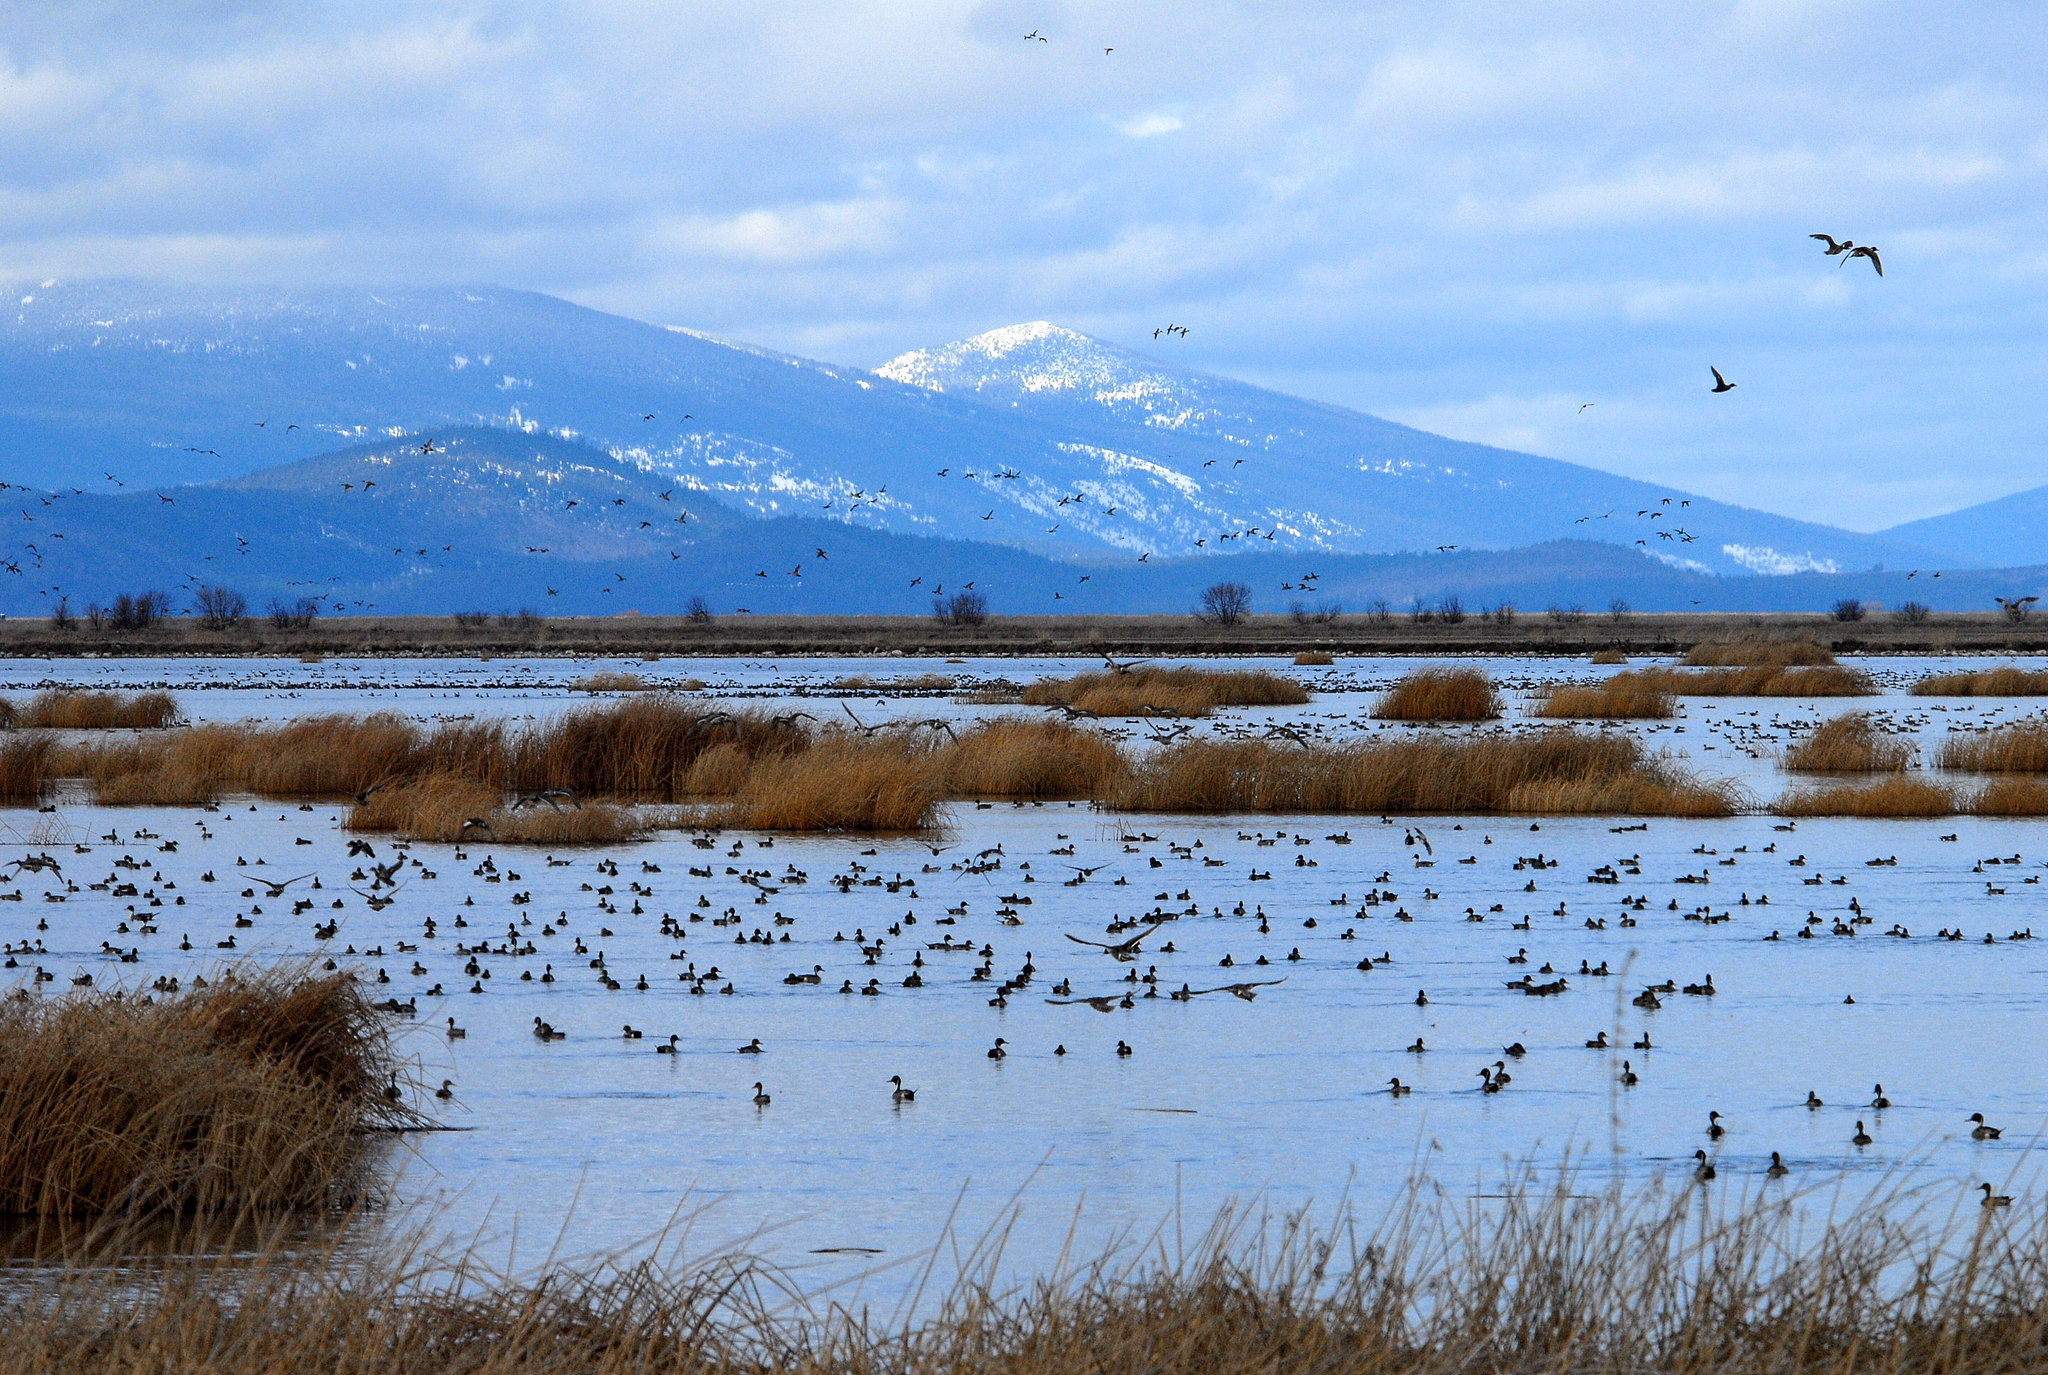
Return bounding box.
[711,738,944,832]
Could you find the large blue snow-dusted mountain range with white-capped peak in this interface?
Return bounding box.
[0,283,1937,576]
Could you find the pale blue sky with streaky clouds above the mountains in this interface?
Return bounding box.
[0,0,2048,531]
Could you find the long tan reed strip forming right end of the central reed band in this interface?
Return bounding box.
[1108,730,1739,816]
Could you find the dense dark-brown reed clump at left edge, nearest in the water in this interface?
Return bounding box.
[0,973,416,1215]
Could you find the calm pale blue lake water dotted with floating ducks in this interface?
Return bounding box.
[0,658,2048,1291]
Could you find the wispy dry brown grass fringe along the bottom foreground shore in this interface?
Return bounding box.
[12,1178,2048,1375]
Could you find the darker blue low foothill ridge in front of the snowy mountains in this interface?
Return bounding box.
[0,426,2048,617]
